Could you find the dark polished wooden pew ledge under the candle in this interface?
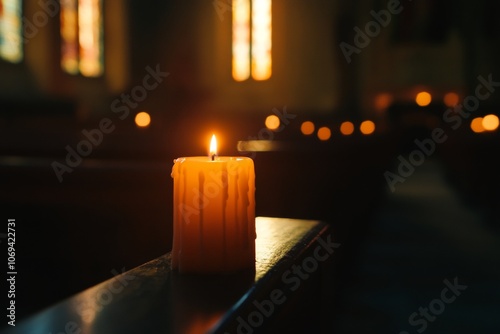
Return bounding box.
[5,217,333,334]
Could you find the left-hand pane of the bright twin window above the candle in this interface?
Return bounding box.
[233,0,250,81]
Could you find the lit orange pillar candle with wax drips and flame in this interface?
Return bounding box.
[172,136,255,273]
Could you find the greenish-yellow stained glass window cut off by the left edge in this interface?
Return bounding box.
[0,0,23,63]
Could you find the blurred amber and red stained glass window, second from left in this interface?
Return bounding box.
[61,0,104,77]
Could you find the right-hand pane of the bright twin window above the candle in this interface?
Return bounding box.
[252,0,272,80]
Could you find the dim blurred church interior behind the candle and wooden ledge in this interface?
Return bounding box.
[0,0,500,334]
